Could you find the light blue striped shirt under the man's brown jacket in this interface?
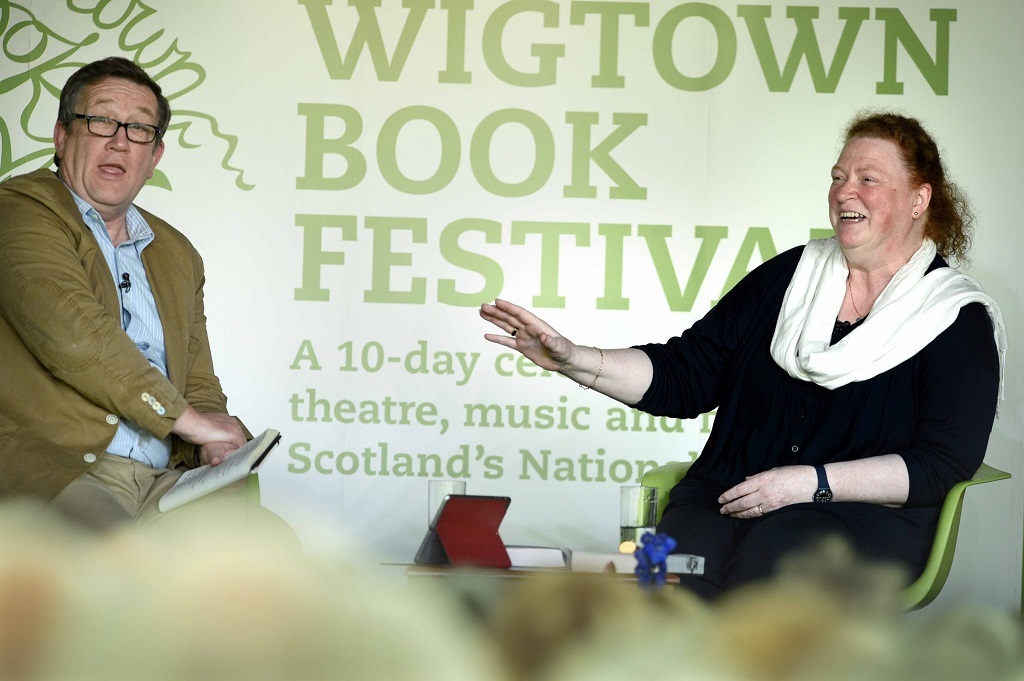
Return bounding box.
[69,187,171,468]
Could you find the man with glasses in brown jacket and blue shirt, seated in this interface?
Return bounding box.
[0,57,248,528]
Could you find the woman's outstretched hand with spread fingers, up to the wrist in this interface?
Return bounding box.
[480,300,575,372]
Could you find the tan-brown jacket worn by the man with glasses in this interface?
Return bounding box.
[0,170,237,500]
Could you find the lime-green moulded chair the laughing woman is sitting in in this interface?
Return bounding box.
[641,461,1010,611]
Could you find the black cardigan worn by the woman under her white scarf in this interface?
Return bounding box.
[635,247,999,509]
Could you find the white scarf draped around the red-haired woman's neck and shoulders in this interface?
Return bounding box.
[771,237,1007,399]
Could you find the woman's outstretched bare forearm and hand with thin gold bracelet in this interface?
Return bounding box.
[480,300,653,405]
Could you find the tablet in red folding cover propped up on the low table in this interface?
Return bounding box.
[415,495,512,567]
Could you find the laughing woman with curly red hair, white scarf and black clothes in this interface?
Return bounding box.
[480,113,1006,598]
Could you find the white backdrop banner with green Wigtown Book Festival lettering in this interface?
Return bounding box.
[0,0,1022,561]
